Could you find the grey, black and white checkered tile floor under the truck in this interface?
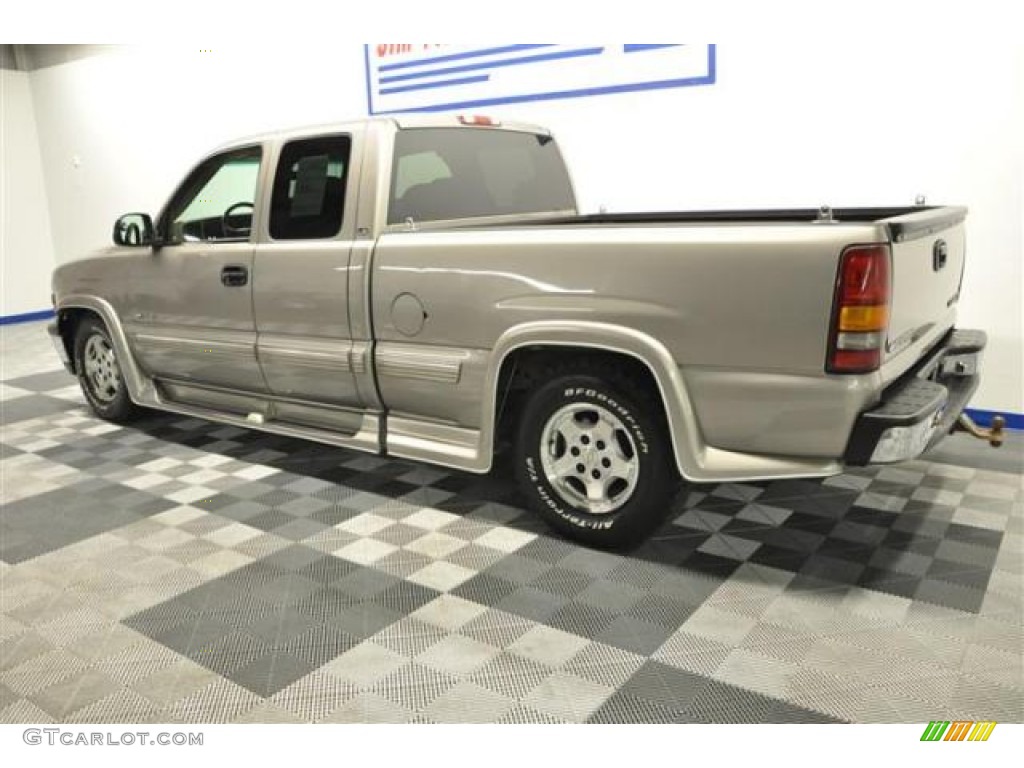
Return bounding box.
[0,324,1024,723]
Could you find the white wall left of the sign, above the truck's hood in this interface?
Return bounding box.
[32,46,366,262]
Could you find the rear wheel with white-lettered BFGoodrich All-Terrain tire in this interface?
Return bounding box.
[515,362,679,549]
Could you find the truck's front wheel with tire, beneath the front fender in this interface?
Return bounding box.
[75,317,140,423]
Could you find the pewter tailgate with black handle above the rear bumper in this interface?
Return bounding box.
[879,207,967,368]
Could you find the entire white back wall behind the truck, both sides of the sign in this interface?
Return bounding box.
[22,41,1024,414]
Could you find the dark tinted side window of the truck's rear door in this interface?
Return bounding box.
[270,136,351,240]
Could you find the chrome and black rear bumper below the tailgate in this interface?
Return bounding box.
[843,330,987,466]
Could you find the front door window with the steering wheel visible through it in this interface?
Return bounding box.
[164,146,260,243]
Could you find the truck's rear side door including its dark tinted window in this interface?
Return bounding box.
[253,133,367,409]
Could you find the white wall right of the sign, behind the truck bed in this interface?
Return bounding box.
[502,41,1024,414]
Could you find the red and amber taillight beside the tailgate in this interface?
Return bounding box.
[825,245,892,374]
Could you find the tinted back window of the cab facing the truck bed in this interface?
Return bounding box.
[388,128,575,224]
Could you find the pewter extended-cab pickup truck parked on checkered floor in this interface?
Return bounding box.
[50,116,985,546]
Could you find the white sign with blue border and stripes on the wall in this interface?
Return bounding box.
[366,43,716,115]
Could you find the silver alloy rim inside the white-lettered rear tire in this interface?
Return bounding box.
[541,402,640,515]
